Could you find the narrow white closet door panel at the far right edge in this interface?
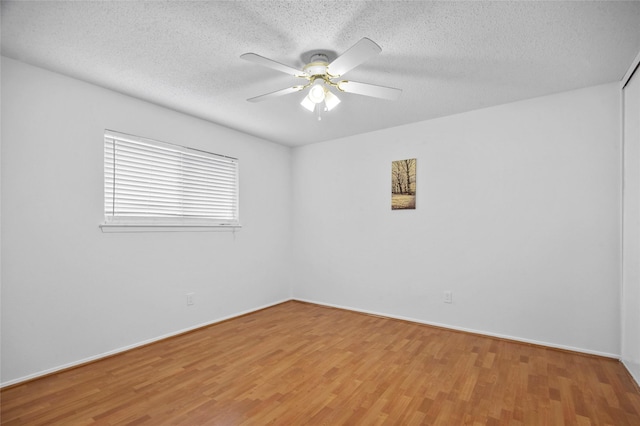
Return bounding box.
[622,63,640,383]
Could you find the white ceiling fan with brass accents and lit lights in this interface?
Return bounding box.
[240,37,402,120]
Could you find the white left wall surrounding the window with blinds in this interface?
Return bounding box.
[1,58,291,384]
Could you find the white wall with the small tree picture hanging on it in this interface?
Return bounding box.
[292,83,621,356]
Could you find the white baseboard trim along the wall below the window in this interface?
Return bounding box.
[0,299,291,389]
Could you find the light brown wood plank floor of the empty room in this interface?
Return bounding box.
[1,302,640,426]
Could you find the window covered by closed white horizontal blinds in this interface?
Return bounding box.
[104,130,240,226]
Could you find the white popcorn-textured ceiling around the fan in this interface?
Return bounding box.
[1,0,640,146]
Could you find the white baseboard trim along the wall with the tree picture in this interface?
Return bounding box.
[293,298,620,360]
